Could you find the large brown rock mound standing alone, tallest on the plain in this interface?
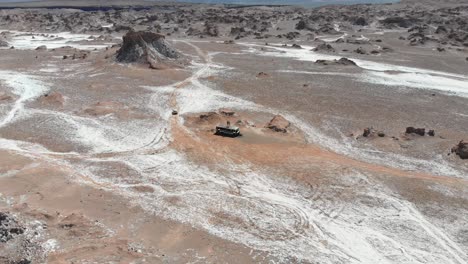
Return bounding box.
[117,31,183,69]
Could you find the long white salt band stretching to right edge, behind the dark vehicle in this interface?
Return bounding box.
[240,43,468,97]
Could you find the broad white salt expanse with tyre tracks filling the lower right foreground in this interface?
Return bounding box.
[77,150,466,263]
